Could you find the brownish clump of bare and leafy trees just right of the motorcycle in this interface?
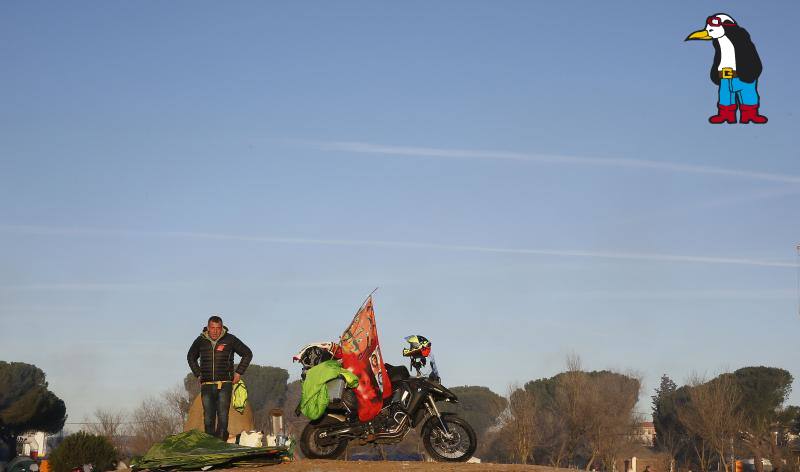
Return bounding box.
[476,357,642,470]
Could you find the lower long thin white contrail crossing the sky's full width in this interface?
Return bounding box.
[0,225,797,268]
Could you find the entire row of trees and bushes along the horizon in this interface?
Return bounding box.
[0,357,800,466]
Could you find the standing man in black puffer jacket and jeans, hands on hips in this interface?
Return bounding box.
[186,315,253,441]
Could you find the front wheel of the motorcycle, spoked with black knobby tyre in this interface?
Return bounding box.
[422,415,478,462]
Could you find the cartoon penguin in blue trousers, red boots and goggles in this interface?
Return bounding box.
[686,13,767,124]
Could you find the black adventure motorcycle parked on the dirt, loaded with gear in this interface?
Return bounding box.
[295,345,477,462]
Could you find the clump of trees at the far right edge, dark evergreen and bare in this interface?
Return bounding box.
[652,367,800,472]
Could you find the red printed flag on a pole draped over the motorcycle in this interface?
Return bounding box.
[341,296,392,421]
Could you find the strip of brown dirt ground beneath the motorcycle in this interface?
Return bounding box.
[222,459,574,472]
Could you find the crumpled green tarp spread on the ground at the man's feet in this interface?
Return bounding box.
[131,429,292,470]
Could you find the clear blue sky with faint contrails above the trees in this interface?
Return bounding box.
[0,1,800,421]
